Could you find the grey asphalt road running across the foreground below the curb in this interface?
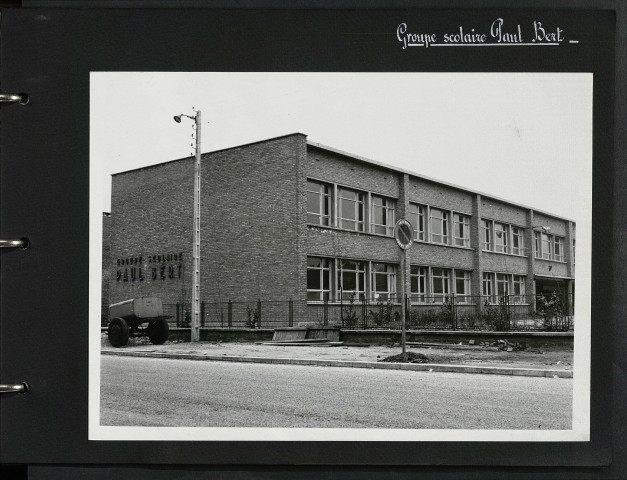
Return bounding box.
[101,356,573,430]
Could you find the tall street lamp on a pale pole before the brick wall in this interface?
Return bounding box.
[174,110,200,342]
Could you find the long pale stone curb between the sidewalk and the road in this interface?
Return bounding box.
[101,350,573,378]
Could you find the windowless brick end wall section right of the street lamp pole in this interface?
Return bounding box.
[200,134,307,301]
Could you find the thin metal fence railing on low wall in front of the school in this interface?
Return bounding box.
[163,294,574,331]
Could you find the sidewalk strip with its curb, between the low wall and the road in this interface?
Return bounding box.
[102,336,573,378]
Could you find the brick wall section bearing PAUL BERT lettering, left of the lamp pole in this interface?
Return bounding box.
[108,158,194,303]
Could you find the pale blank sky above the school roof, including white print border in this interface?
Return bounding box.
[91,72,592,223]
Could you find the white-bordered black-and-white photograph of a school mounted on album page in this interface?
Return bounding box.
[89,71,593,442]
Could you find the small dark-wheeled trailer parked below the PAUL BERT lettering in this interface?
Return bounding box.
[107,297,172,348]
